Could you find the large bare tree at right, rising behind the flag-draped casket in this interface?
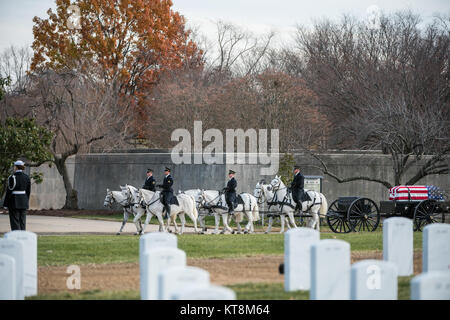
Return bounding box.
[297,12,450,187]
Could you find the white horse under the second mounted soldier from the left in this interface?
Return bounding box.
[135,189,198,234]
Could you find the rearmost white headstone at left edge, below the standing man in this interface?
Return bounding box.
[5,230,38,297]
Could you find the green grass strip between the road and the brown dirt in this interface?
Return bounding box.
[38,232,422,266]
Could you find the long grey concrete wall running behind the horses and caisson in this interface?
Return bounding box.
[32,153,450,209]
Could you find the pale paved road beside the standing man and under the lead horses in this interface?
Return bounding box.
[0,214,200,234]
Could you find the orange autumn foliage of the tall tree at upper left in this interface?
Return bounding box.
[31,0,203,132]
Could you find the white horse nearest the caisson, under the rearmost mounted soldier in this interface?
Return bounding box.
[254,176,328,233]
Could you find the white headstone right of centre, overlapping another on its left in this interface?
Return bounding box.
[309,240,350,300]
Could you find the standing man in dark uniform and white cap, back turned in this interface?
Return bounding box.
[3,160,31,230]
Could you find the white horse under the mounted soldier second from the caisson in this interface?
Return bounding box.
[202,190,259,234]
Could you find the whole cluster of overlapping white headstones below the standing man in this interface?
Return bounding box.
[0,231,37,300]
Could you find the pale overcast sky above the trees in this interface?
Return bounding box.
[0,0,450,51]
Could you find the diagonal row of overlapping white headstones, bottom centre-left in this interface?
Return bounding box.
[139,232,236,300]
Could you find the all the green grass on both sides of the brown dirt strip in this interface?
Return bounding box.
[31,231,422,300]
